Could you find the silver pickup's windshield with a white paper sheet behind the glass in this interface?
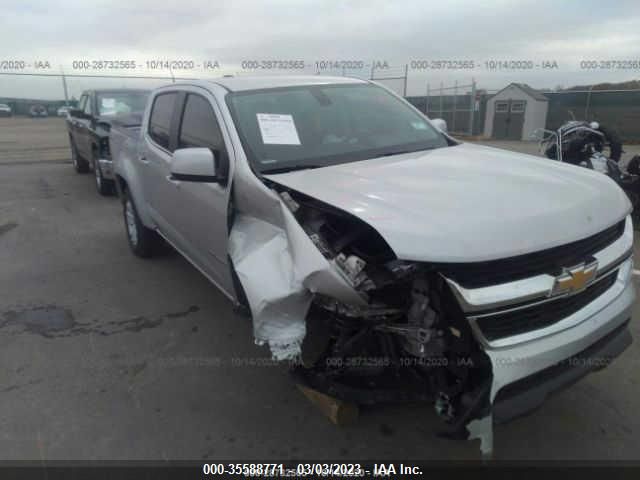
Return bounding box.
[227,84,448,173]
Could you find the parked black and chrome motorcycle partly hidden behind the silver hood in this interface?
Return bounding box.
[534,120,640,228]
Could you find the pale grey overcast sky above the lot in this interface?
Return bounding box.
[0,0,640,98]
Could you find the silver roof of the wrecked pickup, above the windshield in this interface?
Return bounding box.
[188,75,366,92]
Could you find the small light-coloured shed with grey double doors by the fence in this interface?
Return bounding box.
[484,83,549,140]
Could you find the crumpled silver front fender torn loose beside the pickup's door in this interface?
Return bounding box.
[229,179,366,360]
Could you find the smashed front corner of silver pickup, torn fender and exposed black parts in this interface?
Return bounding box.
[230,182,492,453]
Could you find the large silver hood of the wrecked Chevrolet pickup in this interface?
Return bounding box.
[266,144,631,262]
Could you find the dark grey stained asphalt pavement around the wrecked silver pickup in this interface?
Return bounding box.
[0,118,640,461]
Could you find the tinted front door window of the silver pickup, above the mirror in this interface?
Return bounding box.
[178,94,224,151]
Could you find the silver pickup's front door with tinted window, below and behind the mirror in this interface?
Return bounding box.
[161,87,233,292]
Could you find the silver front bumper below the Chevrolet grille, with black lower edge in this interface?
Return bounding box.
[485,259,635,421]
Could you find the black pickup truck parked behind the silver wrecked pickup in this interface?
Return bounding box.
[67,89,149,195]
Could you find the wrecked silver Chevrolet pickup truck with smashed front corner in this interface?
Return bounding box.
[110,76,635,454]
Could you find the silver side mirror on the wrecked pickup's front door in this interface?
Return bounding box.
[171,148,228,183]
